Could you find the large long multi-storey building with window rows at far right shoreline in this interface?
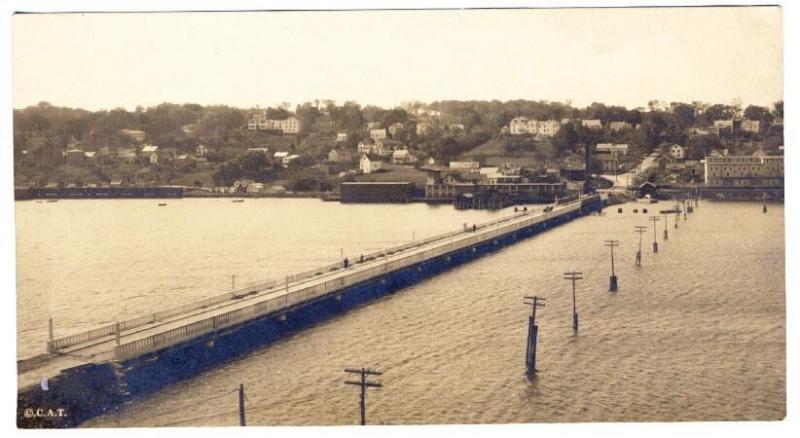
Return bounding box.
[705,155,783,187]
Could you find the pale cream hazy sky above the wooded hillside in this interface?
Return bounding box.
[12,7,783,110]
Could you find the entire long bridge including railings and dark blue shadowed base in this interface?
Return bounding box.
[18,195,604,427]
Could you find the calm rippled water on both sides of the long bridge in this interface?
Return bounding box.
[17,200,786,426]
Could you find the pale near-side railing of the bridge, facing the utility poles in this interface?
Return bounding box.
[109,197,592,360]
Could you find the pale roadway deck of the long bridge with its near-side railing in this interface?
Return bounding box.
[18,201,592,387]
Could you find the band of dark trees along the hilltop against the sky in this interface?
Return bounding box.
[13,100,783,185]
